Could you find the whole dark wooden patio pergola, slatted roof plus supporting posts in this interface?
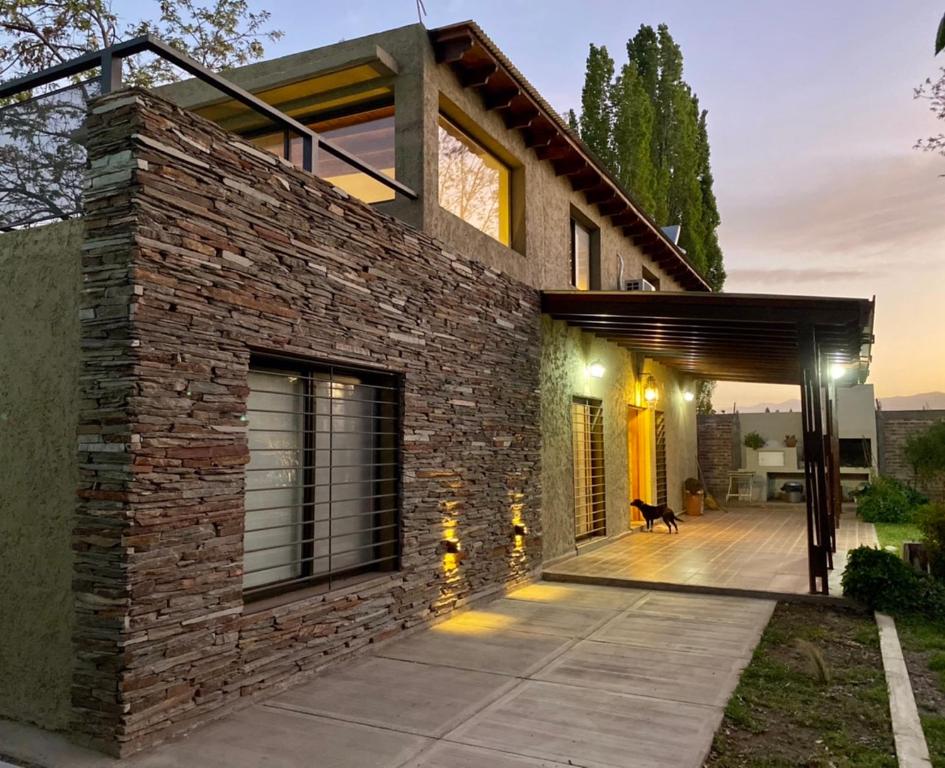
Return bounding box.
[542,291,874,594]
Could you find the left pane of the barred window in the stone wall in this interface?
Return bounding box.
[243,371,304,588]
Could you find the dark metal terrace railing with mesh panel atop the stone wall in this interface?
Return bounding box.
[0,35,417,231]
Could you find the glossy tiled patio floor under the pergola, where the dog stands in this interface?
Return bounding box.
[545,504,876,595]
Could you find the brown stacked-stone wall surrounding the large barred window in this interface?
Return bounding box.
[73,91,541,754]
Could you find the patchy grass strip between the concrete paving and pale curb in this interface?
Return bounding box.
[705,603,897,768]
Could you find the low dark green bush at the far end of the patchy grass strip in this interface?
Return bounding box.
[841,547,945,617]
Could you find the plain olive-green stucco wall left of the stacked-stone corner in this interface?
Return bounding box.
[0,222,83,729]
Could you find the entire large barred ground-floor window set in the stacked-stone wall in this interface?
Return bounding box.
[243,360,400,597]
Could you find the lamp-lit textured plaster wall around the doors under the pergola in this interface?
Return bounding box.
[541,315,696,561]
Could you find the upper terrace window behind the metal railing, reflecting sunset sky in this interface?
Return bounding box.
[253,105,395,203]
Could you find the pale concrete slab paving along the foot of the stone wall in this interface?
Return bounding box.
[0,583,774,768]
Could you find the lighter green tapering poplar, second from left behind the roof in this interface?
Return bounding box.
[610,62,656,211]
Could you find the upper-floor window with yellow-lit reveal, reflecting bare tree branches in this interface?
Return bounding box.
[439,115,512,245]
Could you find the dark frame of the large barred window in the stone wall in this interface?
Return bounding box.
[242,352,404,604]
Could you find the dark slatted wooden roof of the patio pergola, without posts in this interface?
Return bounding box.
[542,291,874,384]
